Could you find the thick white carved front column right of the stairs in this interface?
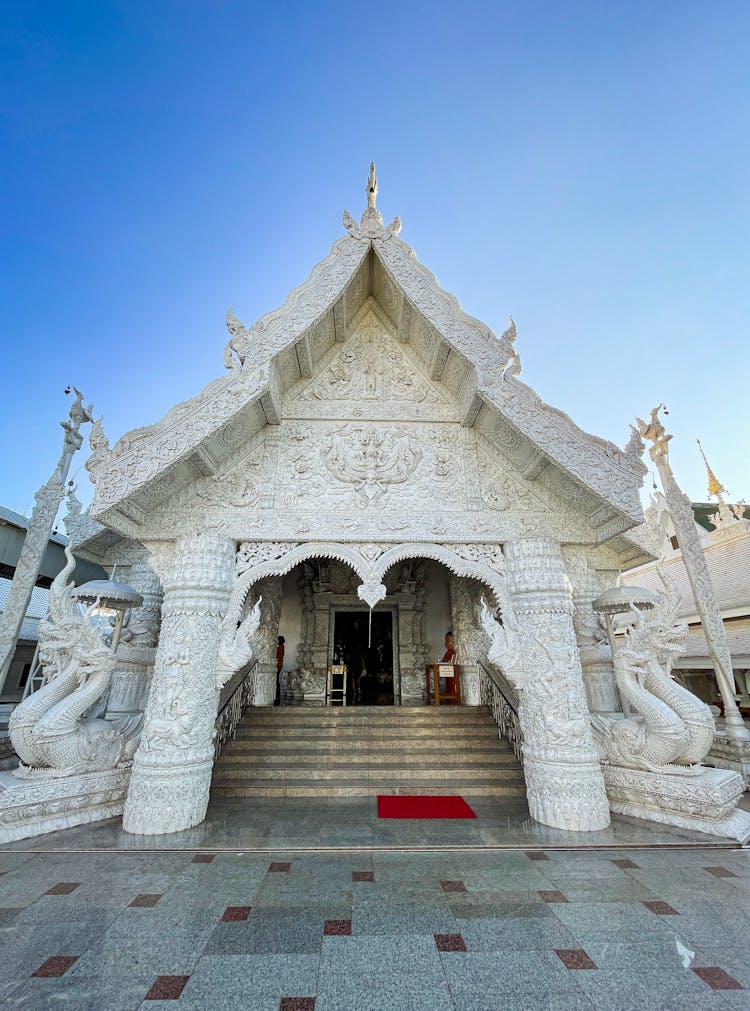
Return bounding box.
[504,538,610,832]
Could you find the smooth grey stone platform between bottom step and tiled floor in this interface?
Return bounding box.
[0,791,748,852]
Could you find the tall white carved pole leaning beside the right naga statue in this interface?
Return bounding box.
[638,403,750,742]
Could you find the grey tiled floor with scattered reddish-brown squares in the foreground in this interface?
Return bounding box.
[0,847,750,1011]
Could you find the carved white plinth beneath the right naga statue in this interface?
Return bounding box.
[603,765,750,843]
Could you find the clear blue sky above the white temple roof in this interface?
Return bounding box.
[0,0,750,510]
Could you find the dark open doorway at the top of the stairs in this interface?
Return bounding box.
[334,611,393,706]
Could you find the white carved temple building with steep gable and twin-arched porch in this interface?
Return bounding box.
[0,172,750,838]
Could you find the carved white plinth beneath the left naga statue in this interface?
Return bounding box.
[0,766,130,843]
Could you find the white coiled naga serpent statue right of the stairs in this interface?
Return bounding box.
[591,583,715,772]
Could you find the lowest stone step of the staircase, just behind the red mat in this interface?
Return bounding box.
[211,779,526,797]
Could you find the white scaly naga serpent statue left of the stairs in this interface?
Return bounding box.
[8,548,143,776]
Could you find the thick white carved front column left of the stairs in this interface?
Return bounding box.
[122,531,236,835]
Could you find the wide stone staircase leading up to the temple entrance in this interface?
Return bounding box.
[211,706,526,797]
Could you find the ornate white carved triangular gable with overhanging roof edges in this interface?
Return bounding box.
[89,163,645,562]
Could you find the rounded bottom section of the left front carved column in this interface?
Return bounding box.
[122,753,213,835]
